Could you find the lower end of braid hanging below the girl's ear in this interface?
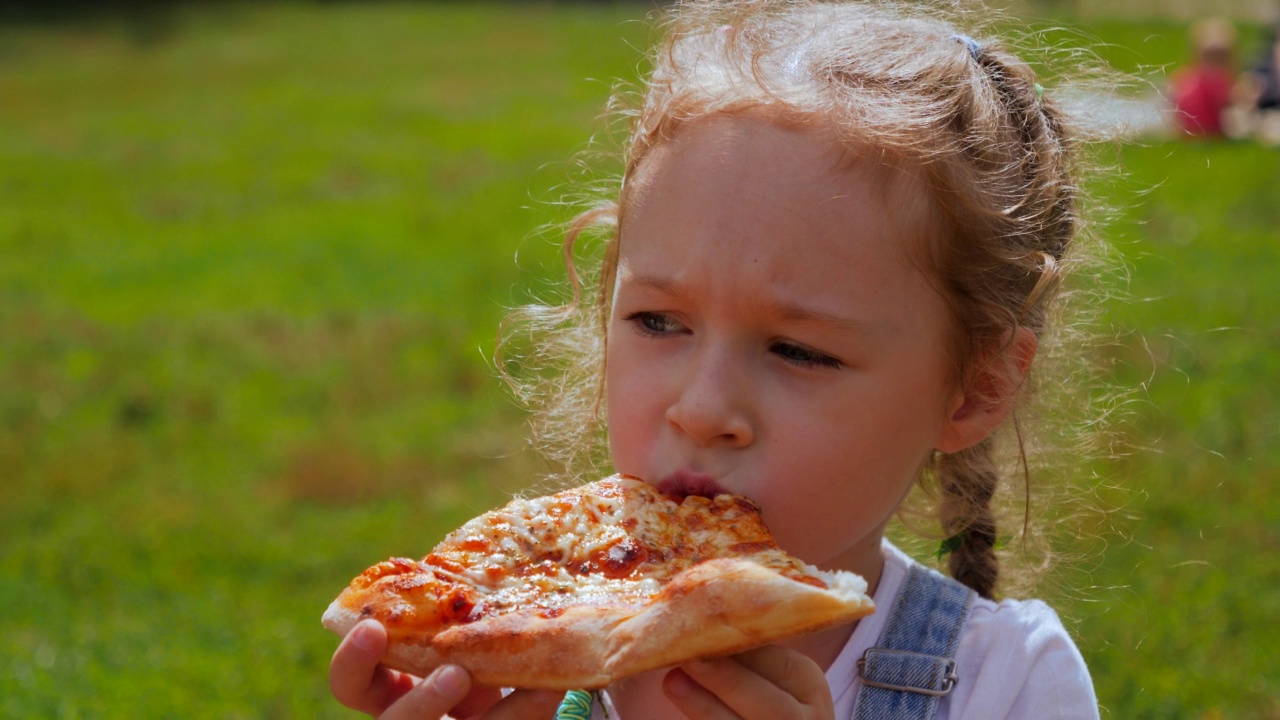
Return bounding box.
[937,438,1000,598]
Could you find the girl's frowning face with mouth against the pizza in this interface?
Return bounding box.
[607,118,963,583]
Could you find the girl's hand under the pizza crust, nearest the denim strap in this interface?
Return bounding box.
[662,646,835,720]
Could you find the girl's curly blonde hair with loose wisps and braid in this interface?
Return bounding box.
[499,0,1121,596]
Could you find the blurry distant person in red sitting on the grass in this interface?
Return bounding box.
[1169,18,1235,137]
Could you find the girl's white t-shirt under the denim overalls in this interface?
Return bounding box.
[593,541,1098,720]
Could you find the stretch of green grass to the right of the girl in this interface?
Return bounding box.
[1076,137,1280,717]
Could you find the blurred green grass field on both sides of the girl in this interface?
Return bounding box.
[0,4,1280,719]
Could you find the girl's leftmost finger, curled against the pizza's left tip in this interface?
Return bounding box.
[329,620,413,715]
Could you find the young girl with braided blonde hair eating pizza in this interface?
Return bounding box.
[330,1,1097,720]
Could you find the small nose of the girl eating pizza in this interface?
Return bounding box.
[667,353,755,447]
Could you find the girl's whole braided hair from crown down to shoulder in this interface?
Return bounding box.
[911,36,1079,597]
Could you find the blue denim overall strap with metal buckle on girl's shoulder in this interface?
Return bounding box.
[854,565,975,720]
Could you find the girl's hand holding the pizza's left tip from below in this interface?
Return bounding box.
[329,620,562,720]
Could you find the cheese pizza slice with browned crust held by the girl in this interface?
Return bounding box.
[323,475,874,689]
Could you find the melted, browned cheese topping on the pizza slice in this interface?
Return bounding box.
[386,477,826,620]
